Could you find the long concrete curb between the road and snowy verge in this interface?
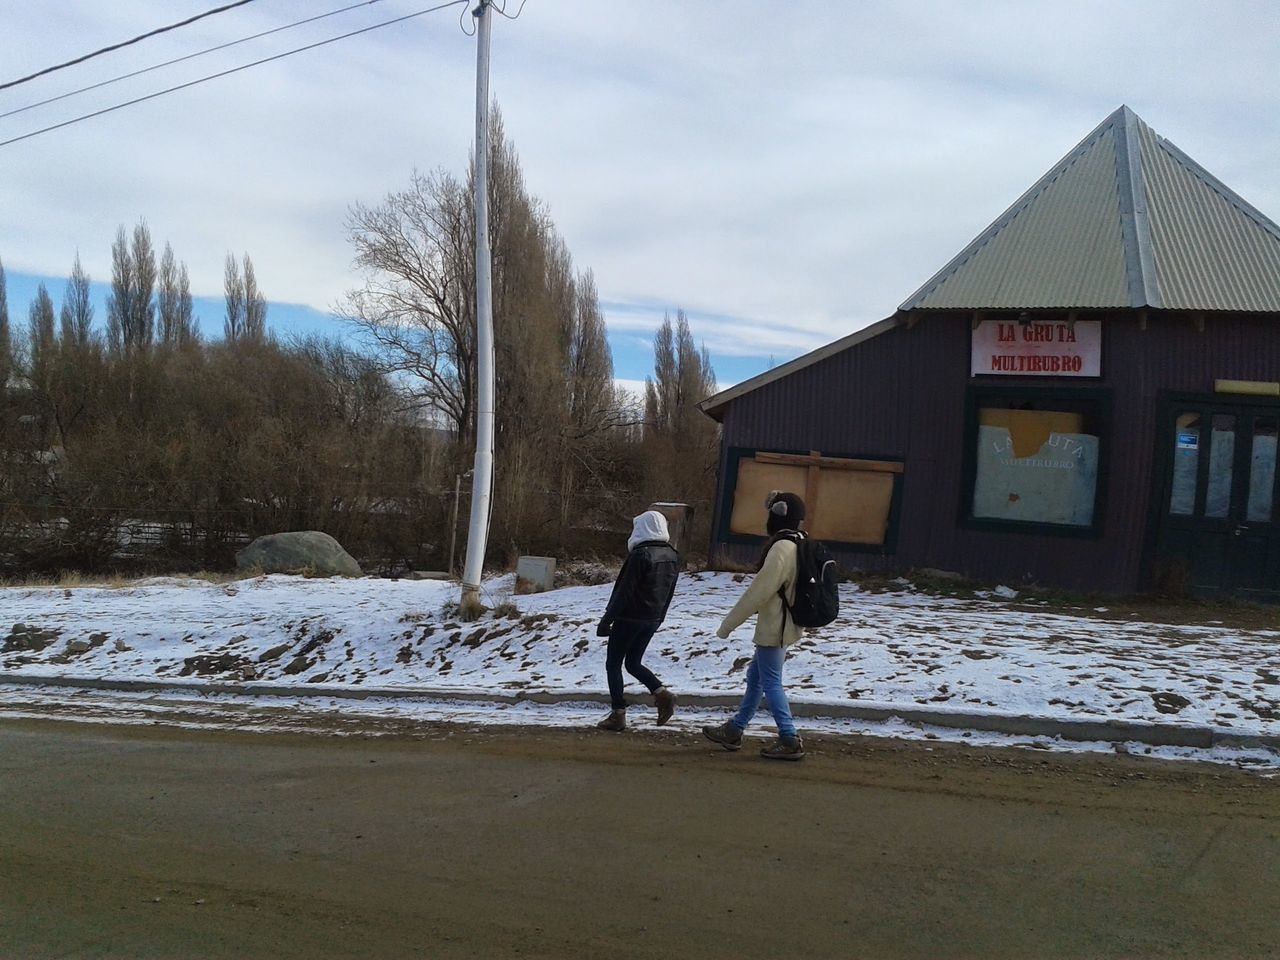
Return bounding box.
[0,673,1280,750]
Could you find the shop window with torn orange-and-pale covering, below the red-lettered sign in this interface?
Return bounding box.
[969,392,1103,530]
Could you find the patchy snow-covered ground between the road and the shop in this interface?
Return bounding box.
[0,573,1280,768]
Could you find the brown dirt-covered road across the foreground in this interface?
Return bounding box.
[0,721,1280,960]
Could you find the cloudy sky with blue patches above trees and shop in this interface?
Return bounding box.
[0,0,1280,384]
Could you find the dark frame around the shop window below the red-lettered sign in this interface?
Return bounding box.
[957,383,1112,540]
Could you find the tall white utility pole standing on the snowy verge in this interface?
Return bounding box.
[462,0,494,608]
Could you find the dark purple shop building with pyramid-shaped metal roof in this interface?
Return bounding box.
[701,106,1280,599]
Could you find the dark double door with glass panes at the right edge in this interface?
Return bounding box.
[1156,397,1280,600]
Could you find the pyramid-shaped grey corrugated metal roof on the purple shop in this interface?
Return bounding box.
[901,106,1280,311]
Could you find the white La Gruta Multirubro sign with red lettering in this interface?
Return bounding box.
[969,320,1102,376]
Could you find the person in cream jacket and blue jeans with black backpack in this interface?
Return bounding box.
[703,490,804,760]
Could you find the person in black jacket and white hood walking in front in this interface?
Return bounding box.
[595,509,680,730]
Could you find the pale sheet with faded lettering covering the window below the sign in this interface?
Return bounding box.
[973,415,1098,526]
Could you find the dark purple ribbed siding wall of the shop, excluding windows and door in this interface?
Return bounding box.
[712,315,1280,593]
